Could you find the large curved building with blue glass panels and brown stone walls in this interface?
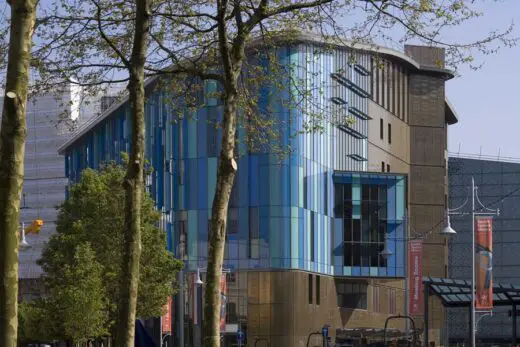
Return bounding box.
[60,34,457,346]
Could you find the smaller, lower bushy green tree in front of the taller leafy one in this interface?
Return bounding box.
[21,242,108,343]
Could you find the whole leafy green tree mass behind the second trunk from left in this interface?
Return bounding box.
[19,164,182,342]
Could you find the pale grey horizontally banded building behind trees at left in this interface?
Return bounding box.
[0,85,117,299]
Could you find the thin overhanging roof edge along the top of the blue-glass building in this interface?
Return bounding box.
[58,32,458,155]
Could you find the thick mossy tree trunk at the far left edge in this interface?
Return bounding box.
[0,0,38,347]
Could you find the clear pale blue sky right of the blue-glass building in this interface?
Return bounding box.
[430,0,520,158]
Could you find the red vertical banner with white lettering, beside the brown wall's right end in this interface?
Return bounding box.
[408,240,424,316]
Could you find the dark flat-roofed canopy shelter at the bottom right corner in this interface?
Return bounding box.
[423,277,520,346]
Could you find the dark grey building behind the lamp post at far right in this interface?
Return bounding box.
[448,155,520,345]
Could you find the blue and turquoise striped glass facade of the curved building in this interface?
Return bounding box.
[66,44,406,277]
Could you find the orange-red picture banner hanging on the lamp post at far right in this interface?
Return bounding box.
[475,217,493,310]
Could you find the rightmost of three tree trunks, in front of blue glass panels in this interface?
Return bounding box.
[204,87,238,347]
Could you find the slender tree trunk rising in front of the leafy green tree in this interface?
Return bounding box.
[116,0,151,347]
